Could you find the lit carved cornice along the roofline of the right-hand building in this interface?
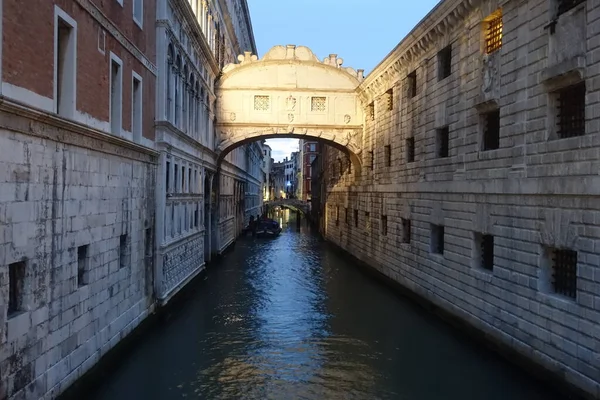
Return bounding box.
[358,0,481,103]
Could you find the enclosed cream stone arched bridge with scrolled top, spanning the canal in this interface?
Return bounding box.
[216,45,363,174]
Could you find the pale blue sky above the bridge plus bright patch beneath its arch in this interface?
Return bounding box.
[248,0,438,161]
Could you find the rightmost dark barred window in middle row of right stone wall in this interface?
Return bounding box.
[557,82,585,139]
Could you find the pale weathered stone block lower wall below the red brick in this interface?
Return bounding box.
[0,111,155,399]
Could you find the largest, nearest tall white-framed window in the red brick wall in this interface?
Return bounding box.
[54,8,77,118]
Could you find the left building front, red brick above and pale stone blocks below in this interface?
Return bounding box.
[0,0,157,399]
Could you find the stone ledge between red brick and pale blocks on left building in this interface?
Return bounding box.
[0,96,158,163]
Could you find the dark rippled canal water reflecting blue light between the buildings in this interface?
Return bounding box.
[78,214,562,400]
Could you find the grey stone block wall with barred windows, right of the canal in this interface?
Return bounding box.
[324,0,600,397]
